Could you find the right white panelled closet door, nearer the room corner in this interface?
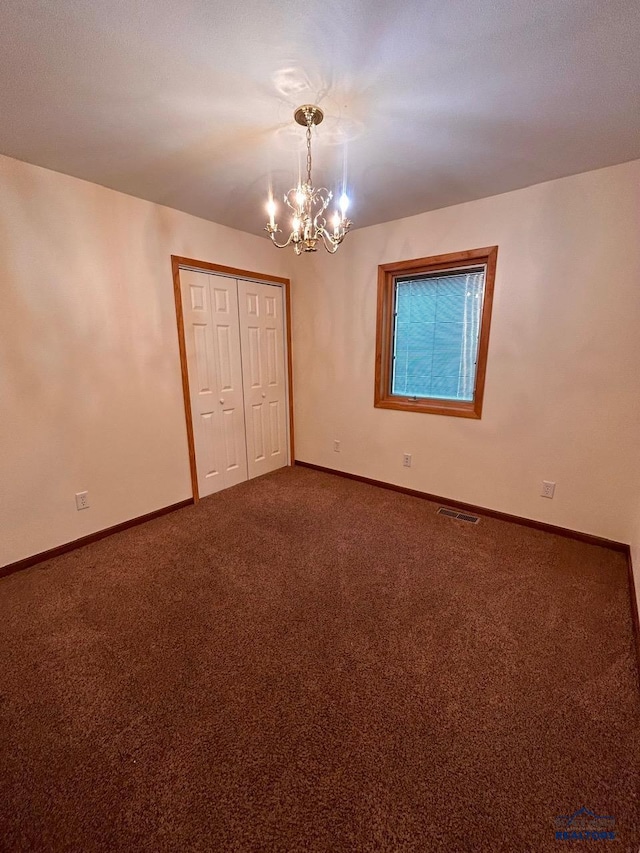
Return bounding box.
[238,280,288,478]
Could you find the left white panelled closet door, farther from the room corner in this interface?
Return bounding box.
[180,270,247,497]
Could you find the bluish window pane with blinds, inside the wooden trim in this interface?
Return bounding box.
[391,270,484,401]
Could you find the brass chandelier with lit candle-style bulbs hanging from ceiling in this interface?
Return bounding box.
[264,104,352,255]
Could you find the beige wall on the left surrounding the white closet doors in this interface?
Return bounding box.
[0,157,286,565]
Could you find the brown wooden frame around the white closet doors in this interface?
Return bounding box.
[171,255,295,503]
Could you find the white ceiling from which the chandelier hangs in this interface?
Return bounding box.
[0,0,640,233]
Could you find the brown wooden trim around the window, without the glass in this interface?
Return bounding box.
[374,246,498,419]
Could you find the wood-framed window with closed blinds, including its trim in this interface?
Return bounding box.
[374,246,498,418]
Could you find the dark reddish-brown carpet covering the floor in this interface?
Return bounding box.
[0,468,640,853]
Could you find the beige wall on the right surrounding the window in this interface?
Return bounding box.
[293,161,640,542]
